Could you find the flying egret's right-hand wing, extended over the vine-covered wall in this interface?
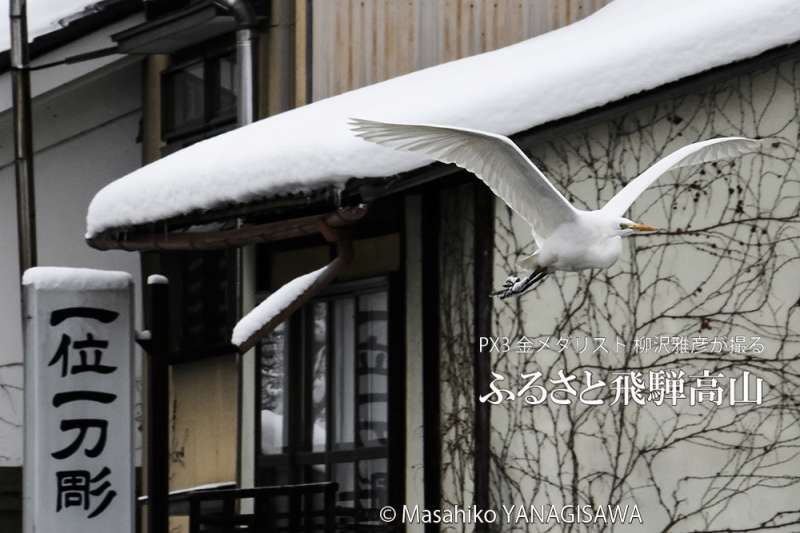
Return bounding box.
[603,137,763,216]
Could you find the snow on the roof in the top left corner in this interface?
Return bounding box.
[0,0,99,50]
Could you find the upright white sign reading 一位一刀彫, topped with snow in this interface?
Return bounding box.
[22,267,134,533]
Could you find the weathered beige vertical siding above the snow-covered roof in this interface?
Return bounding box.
[311,0,610,100]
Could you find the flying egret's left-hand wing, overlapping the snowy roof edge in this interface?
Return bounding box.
[350,119,576,240]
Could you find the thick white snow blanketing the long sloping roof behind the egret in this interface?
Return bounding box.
[87,0,800,237]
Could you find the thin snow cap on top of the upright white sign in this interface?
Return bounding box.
[22,267,133,291]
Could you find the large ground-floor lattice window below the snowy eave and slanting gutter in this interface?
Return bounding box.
[257,278,403,525]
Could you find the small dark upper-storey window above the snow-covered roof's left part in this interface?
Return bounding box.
[162,49,237,142]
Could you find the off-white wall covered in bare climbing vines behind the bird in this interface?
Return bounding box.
[486,56,800,532]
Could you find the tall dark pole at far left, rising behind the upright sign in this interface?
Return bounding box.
[9,0,37,275]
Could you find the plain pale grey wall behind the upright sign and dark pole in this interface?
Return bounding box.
[0,62,141,466]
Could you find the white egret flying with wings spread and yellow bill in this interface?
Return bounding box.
[350,119,761,298]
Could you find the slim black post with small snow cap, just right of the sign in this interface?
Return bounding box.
[146,276,169,533]
